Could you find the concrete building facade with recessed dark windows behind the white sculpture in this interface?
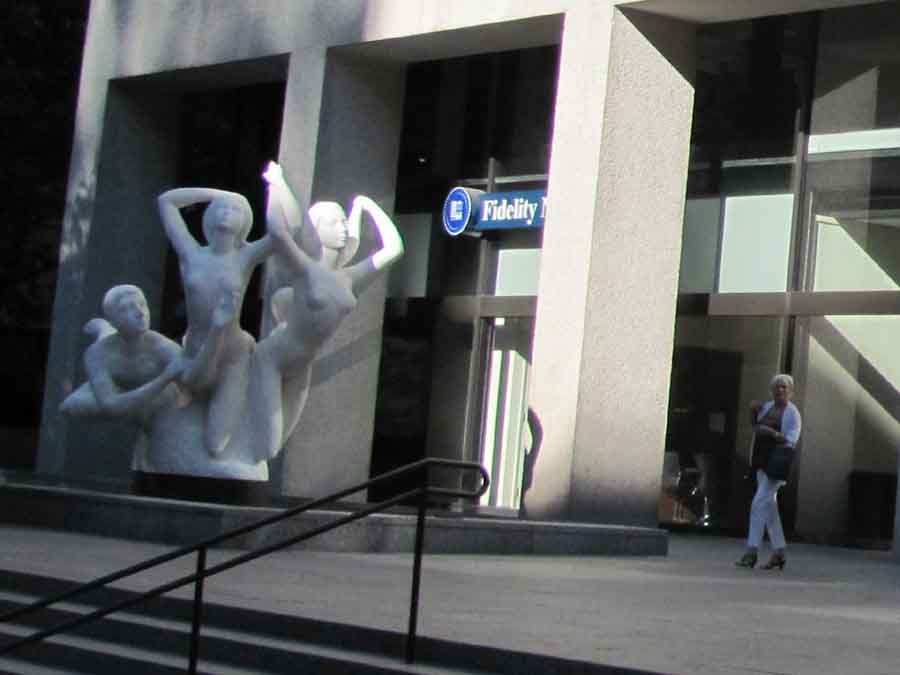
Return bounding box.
[36,0,900,556]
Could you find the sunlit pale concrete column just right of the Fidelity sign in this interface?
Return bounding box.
[527,3,695,526]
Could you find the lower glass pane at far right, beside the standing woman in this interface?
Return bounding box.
[797,316,900,541]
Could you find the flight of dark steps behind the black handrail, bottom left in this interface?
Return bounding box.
[0,572,660,675]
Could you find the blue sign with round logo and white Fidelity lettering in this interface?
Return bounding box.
[443,187,547,237]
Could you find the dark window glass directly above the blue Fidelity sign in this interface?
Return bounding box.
[397,46,559,213]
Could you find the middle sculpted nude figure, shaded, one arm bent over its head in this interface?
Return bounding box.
[158,188,271,457]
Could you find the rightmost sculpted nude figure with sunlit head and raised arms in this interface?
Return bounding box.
[248,162,403,457]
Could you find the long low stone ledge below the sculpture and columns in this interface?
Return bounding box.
[0,481,668,556]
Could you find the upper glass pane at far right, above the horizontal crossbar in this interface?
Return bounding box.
[806,3,900,291]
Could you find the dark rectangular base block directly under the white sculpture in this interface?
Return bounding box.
[131,471,270,506]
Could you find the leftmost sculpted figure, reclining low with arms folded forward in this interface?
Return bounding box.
[62,285,184,425]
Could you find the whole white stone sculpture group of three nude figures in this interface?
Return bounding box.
[63,162,403,481]
